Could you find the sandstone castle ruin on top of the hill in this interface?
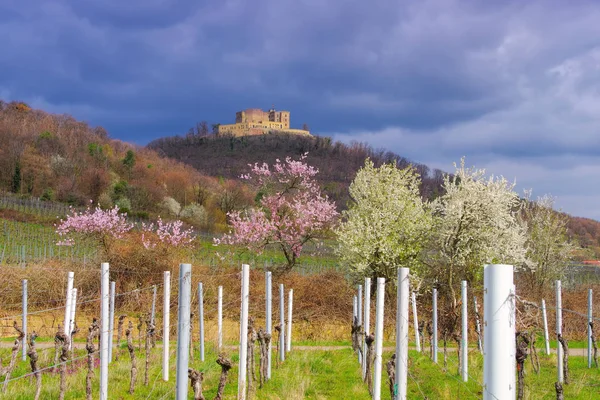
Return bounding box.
[219,107,310,136]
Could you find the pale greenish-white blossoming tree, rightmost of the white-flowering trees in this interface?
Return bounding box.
[523,191,575,296]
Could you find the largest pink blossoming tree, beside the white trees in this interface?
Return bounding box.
[215,154,338,270]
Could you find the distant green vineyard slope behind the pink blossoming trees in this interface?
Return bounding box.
[0,193,344,274]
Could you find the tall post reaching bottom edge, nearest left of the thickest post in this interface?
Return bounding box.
[394,268,414,400]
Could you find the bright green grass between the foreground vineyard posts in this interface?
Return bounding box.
[0,342,600,400]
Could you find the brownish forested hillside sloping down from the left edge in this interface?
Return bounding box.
[0,101,253,230]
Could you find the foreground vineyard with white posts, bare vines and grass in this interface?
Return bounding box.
[0,265,600,399]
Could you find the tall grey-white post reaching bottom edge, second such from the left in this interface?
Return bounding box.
[175,264,192,400]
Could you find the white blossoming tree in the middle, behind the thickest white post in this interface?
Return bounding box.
[427,158,526,310]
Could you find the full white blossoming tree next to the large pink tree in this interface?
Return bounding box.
[336,159,431,279]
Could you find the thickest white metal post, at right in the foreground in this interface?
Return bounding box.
[483,264,516,400]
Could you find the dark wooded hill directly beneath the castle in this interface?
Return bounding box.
[148,133,444,208]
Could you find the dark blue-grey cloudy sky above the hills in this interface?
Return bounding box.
[0,0,600,219]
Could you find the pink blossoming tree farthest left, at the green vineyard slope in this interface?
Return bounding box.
[55,206,133,254]
